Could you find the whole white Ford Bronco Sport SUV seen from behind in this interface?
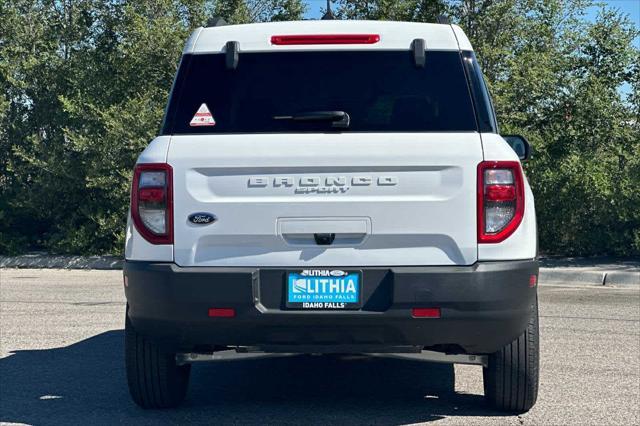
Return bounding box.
[124,17,538,412]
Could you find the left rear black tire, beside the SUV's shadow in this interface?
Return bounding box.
[124,315,191,408]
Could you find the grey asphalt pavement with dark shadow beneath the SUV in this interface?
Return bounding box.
[0,269,640,425]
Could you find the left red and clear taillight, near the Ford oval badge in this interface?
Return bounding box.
[131,163,173,244]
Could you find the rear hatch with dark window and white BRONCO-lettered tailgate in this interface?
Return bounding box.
[164,50,482,267]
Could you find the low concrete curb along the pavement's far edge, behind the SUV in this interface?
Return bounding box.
[0,254,640,287]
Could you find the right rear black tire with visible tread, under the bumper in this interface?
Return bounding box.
[482,300,540,413]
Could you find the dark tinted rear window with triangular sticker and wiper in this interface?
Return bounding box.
[163,51,477,134]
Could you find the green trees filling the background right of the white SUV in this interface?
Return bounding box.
[338,0,640,255]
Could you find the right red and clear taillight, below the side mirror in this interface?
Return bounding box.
[478,161,524,243]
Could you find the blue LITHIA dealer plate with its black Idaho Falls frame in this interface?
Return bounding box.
[284,268,363,311]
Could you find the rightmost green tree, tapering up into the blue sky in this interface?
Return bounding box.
[531,10,640,255]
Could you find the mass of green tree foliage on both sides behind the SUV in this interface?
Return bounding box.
[0,0,640,255]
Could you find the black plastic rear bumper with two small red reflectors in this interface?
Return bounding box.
[124,260,538,354]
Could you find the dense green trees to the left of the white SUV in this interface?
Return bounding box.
[0,0,304,254]
